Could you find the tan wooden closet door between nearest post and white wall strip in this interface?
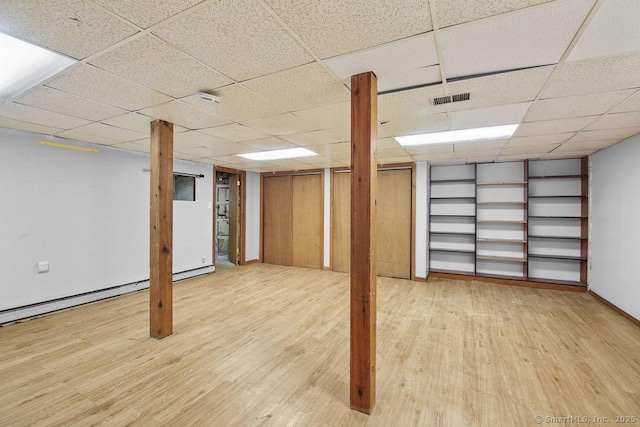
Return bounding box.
[376,169,411,279]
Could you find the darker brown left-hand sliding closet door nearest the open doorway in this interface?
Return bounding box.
[262,176,293,265]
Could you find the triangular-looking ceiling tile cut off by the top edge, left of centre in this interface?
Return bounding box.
[94,0,202,28]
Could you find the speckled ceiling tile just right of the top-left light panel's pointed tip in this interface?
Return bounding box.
[90,35,233,98]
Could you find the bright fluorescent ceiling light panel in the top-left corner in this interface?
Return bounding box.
[0,33,76,99]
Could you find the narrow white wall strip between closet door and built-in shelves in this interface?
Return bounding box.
[415,162,429,279]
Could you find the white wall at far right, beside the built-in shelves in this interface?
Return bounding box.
[589,135,640,319]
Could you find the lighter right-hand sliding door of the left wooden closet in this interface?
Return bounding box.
[293,174,324,268]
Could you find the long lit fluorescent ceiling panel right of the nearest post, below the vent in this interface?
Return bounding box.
[396,124,518,147]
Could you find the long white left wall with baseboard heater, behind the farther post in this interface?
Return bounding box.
[0,128,213,311]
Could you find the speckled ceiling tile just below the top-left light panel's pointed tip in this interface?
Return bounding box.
[47,65,171,111]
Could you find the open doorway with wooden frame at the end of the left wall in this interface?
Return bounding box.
[214,168,244,270]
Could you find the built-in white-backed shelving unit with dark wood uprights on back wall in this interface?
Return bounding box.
[429,158,588,286]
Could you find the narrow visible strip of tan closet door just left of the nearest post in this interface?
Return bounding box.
[331,172,351,273]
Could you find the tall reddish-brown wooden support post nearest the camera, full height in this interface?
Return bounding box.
[351,72,378,414]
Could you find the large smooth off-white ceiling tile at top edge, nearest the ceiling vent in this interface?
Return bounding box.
[440,0,595,78]
